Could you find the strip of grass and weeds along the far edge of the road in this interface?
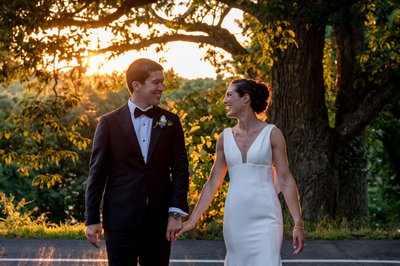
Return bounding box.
[0,192,400,240]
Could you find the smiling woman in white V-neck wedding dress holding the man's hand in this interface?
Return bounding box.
[176,79,304,266]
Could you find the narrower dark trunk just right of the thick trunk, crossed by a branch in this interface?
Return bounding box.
[334,8,368,219]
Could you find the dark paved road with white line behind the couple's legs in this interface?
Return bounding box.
[0,238,400,266]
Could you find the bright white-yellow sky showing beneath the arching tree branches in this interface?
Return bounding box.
[88,9,242,79]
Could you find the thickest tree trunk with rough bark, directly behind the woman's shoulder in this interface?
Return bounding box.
[269,23,336,221]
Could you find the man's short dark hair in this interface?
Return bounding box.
[126,58,163,93]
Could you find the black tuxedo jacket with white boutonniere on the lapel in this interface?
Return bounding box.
[86,104,189,230]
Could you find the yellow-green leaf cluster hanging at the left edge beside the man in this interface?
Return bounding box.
[0,88,90,188]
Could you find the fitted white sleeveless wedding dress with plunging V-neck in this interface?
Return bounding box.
[224,124,283,266]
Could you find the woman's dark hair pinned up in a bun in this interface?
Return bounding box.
[231,79,270,114]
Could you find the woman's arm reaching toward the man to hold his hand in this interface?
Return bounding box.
[176,133,228,237]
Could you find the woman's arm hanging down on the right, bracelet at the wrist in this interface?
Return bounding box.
[271,128,304,254]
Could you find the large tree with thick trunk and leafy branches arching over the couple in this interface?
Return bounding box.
[0,0,400,221]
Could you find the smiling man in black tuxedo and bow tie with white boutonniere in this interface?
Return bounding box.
[86,58,189,266]
